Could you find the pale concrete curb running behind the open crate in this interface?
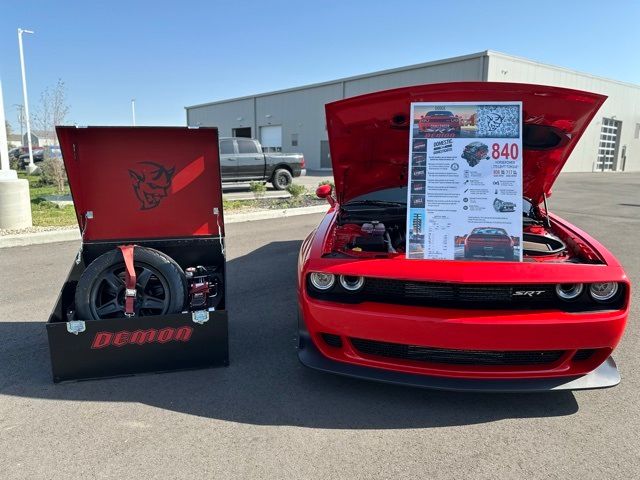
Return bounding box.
[0,205,329,248]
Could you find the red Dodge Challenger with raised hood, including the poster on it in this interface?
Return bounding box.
[298,82,630,391]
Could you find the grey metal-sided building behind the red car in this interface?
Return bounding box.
[186,51,640,172]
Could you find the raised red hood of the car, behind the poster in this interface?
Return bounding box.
[326,82,607,204]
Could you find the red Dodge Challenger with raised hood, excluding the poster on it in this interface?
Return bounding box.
[298,82,630,391]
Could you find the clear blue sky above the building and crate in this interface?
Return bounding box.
[0,0,640,126]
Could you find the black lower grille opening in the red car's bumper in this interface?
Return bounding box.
[350,338,565,366]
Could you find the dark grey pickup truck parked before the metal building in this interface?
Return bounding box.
[220,138,306,190]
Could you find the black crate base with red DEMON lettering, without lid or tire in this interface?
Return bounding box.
[47,237,229,382]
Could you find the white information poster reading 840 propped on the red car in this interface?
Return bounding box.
[406,102,522,261]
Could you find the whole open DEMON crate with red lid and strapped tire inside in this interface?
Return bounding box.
[47,127,228,382]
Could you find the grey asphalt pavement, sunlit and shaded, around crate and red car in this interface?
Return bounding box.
[0,174,640,480]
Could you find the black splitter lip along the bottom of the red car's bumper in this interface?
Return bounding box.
[298,328,620,393]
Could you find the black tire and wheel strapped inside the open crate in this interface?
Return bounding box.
[75,247,187,320]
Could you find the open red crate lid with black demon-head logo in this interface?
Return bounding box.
[56,127,224,241]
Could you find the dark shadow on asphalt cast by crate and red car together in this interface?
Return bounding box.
[0,241,578,429]
